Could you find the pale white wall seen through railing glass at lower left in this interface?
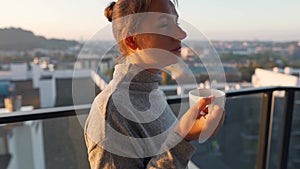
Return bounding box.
[8,121,45,169]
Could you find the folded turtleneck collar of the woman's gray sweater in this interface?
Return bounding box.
[113,64,161,92]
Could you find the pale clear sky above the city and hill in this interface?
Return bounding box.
[0,0,300,41]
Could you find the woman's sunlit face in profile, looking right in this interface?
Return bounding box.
[125,0,186,69]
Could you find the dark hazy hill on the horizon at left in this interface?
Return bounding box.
[0,27,79,50]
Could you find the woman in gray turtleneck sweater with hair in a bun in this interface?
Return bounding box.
[85,0,224,169]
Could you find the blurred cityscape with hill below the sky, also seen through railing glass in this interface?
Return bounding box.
[0,28,300,169]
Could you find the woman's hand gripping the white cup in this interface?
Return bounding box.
[174,97,225,142]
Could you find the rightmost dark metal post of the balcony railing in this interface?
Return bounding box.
[278,90,295,169]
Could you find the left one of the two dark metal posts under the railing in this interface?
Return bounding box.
[257,91,274,169]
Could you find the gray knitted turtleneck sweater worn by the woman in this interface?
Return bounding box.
[85,64,194,169]
